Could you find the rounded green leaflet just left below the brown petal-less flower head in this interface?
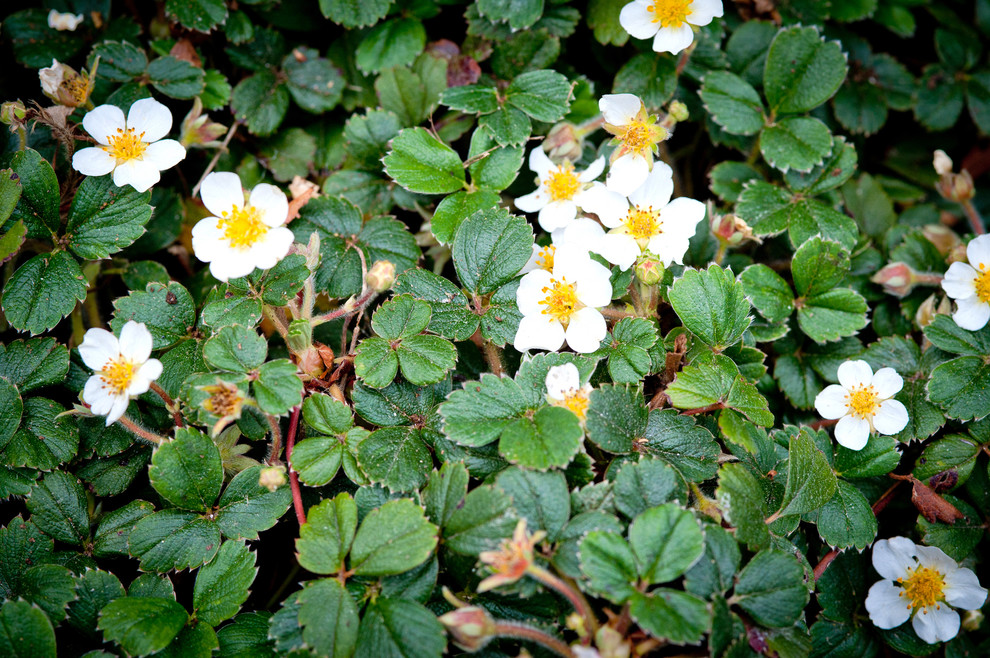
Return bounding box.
[148,427,223,512]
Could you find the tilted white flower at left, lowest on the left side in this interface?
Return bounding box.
[79,320,162,426]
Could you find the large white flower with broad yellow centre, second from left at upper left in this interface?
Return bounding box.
[192,172,293,281]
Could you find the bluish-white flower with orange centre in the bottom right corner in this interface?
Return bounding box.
[866,537,987,644]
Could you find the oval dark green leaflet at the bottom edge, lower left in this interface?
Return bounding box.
[99,596,189,655]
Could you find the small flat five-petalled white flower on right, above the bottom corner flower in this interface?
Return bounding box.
[815,361,908,450]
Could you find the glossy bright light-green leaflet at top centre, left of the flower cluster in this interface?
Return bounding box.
[383,128,464,194]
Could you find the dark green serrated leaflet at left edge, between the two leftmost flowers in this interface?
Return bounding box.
[2,251,86,335]
